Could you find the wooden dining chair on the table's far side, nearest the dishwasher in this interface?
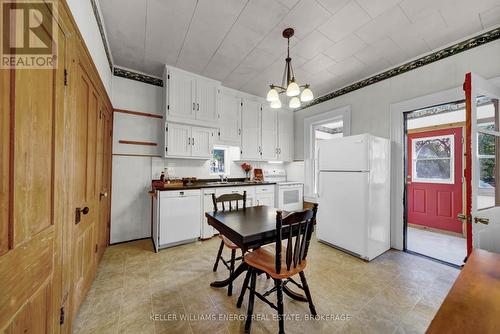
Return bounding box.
[212,191,247,296]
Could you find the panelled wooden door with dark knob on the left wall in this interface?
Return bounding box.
[72,57,102,310]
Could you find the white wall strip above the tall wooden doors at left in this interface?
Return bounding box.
[66,0,113,95]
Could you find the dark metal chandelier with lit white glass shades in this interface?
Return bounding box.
[267,28,314,109]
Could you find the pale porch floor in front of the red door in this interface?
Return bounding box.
[407,227,467,266]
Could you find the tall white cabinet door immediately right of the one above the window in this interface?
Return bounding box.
[241,100,261,160]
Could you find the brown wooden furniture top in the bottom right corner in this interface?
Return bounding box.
[427,249,500,334]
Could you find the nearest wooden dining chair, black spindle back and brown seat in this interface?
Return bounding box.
[236,204,318,334]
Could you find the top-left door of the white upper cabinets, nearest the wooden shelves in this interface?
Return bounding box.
[167,70,196,119]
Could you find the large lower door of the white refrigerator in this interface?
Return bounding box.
[316,172,369,257]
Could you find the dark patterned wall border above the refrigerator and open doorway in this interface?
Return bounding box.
[297,27,500,111]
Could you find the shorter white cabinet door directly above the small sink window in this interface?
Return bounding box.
[218,94,241,146]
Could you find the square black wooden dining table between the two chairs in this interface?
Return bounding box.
[205,205,307,302]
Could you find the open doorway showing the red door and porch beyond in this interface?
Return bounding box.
[404,101,467,266]
